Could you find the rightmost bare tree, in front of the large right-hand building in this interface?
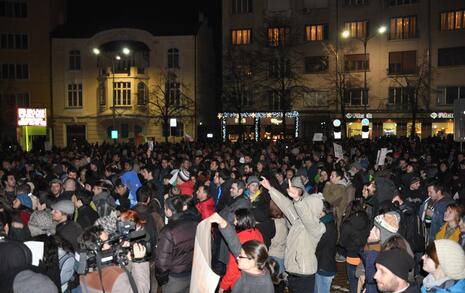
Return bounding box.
[388,54,433,138]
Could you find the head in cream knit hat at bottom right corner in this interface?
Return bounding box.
[422,239,465,280]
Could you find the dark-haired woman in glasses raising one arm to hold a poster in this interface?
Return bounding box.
[209,213,279,293]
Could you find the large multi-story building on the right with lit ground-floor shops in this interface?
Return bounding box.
[218,0,465,138]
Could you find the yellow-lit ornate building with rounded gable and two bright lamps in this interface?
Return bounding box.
[52,16,216,146]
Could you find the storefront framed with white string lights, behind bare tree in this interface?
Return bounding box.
[218,111,299,141]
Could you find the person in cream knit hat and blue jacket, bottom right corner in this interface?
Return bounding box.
[421,239,465,293]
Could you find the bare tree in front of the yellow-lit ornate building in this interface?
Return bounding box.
[147,72,195,142]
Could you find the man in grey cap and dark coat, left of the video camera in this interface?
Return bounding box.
[52,199,82,251]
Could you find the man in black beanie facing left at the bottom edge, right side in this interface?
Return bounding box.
[374,249,421,293]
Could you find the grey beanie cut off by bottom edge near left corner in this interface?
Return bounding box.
[13,270,58,293]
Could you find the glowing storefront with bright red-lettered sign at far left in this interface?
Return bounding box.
[17,108,47,151]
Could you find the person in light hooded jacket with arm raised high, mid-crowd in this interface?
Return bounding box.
[260,177,326,293]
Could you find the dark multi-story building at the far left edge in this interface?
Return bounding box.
[0,0,66,147]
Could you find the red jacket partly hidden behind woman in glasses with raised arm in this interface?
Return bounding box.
[220,229,263,290]
